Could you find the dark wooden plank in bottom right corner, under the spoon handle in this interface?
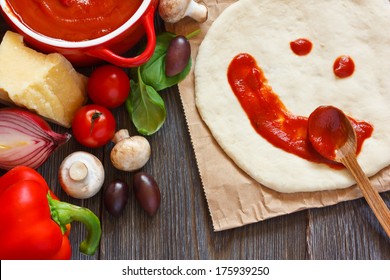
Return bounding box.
[307,192,390,260]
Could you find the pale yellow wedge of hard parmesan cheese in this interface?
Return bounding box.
[0,31,87,127]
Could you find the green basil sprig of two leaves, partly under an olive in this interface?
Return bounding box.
[126,31,199,135]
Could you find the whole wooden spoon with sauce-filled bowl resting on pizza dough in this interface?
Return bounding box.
[308,106,390,237]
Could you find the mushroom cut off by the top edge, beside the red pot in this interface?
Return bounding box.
[158,0,208,23]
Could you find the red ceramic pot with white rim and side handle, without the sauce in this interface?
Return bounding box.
[0,0,158,67]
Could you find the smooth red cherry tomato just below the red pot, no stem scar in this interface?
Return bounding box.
[87,65,130,109]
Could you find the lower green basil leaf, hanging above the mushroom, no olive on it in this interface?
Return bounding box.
[126,70,166,135]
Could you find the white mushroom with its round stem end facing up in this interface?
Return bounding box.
[59,151,104,199]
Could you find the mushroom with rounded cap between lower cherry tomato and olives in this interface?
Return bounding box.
[110,129,151,171]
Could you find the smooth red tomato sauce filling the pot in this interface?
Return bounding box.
[7,0,142,42]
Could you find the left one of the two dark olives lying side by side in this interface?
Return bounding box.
[104,180,129,217]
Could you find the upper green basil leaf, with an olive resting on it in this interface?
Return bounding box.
[140,32,192,91]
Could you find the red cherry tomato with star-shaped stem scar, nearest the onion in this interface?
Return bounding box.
[72,104,116,148]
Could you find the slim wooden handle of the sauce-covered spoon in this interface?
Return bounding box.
[340,154,390,237]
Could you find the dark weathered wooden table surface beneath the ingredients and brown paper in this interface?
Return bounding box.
[0,11,390,260]
